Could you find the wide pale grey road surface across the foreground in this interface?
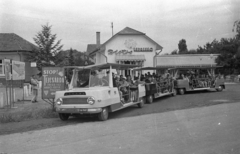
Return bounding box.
[0,100,240,154]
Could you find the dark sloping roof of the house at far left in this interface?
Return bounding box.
[0,33,36,52]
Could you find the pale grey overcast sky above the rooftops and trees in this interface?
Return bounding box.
[0,0,240,54]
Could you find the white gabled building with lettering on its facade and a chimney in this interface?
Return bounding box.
[87,27,163,74]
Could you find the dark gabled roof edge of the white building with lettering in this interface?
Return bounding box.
[87,27,163,55]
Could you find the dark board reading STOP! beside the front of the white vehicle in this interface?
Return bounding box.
[42,67,65,107]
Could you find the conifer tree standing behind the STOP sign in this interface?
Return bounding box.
[28,24,63,71]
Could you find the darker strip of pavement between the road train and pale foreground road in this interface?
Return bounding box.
[0,84,240,135]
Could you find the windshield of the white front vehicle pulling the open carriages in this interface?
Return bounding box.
[71,69,109,88]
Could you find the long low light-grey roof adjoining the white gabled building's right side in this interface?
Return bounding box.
[156,54,218,68]
